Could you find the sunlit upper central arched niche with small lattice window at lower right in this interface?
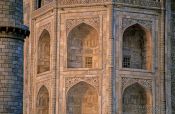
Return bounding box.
[67,23,100,68]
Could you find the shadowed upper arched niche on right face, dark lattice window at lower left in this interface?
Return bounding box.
[122,24,152,70]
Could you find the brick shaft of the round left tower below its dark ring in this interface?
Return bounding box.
[0,37,23,114]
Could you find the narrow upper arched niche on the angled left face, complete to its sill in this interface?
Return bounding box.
[37,30,50,74]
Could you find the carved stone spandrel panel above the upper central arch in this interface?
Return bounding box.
[66,17,100,34]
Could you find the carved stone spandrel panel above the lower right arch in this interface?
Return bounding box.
[122,77,152,91]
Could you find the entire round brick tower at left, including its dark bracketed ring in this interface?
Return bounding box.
[0,0,29,114]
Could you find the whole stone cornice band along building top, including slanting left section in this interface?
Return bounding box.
[32,0,163,15]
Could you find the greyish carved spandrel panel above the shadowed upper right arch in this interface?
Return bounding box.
[122,18,153,31]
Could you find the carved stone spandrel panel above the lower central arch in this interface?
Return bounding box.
[65,77,99,93]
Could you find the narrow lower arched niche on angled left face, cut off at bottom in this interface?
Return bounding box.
[36,86,49,114]
